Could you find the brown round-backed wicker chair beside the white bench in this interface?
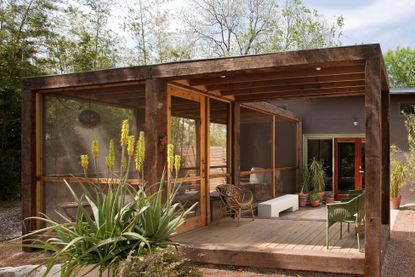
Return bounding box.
[216,184,254,226]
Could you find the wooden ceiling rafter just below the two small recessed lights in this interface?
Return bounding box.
[206,70,365,91]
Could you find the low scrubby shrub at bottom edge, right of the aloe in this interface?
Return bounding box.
[117,247,202,277]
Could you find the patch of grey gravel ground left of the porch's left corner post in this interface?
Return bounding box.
[0,201,22,241]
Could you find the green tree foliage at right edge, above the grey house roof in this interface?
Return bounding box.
[384,47,415,88]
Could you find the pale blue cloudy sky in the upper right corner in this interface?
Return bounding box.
[303,0,415,52]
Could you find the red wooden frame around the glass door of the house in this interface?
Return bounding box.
[333,137,366,198]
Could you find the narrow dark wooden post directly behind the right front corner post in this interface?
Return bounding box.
[382,91,390,226]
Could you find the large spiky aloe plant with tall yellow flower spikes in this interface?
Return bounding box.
[13,120,196,276]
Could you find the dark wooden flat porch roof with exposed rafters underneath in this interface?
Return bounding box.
[25,44,389,107]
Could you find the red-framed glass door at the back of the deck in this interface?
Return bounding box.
[334,138,365,199]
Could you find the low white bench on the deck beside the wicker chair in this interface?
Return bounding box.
[258,194,298,218]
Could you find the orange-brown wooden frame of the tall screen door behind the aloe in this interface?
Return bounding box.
[167,84,207,233]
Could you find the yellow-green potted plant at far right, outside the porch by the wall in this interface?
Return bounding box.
[390,160,409,209]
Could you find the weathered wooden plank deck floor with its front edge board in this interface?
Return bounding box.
[173,219,365,274]
